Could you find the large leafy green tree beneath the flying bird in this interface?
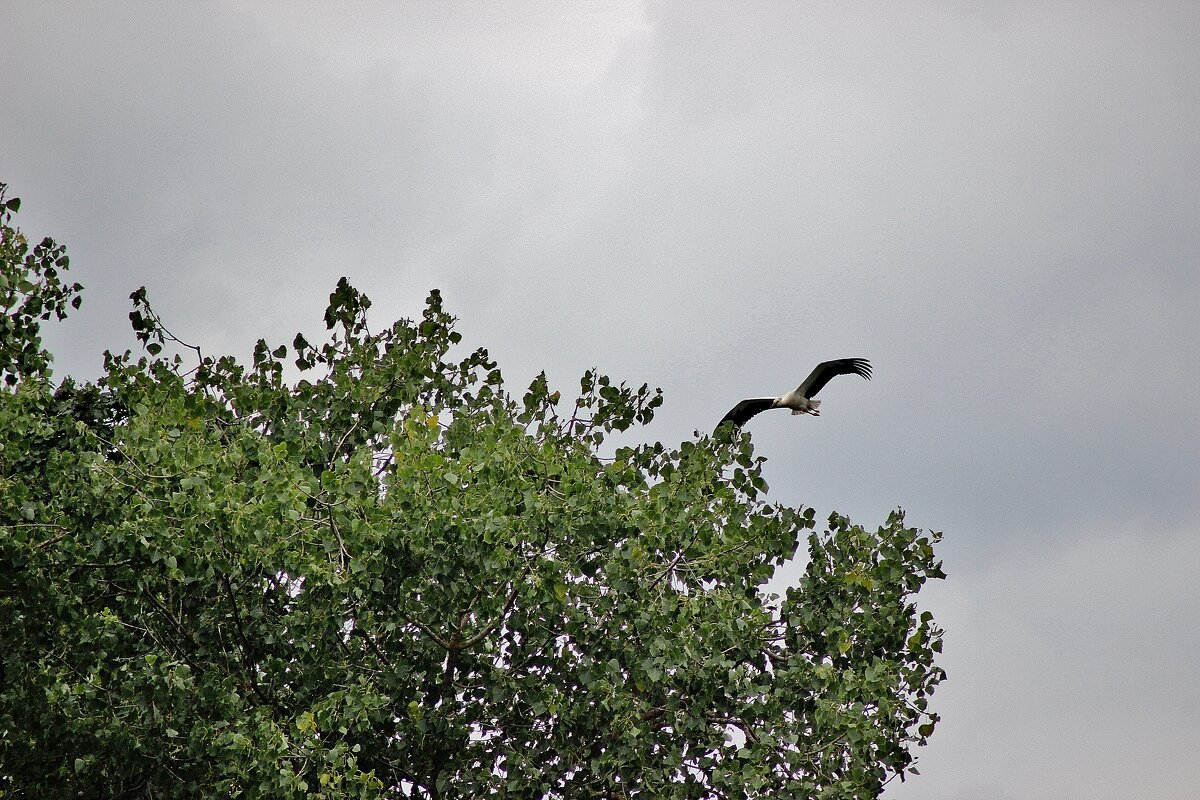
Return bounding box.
[0,193,944,799]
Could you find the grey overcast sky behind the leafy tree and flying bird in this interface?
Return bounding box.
[0,0,1200,800]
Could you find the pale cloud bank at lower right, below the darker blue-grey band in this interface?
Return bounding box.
[889,517,1200,800]
